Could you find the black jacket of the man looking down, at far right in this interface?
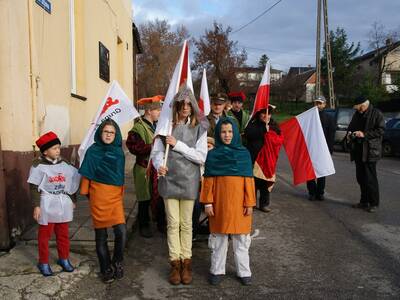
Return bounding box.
[348,104,385,162]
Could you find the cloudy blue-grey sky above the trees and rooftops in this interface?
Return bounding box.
[132,0,400,70]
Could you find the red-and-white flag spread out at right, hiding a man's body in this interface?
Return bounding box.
[280,107,335,185]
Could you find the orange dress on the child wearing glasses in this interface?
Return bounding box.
[80,177,125,228]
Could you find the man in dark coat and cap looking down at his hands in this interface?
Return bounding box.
[347,96,385,212]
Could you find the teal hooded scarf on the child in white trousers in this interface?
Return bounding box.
[204,118,253,177]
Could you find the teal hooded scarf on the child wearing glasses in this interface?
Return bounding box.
[79,119,125,186]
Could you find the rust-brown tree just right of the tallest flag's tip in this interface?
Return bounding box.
[193,22,247,93]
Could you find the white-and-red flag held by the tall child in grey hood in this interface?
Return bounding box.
[154,41,193,136]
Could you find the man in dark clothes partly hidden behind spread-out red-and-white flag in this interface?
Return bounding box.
[307,96,336,201]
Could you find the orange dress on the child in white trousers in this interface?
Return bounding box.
[200,176,256,234]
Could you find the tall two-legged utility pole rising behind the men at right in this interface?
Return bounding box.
[315,0,336,108]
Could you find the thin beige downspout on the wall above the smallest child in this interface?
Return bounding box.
[27,0,39,152]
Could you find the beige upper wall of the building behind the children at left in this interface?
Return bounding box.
[0,0,134,151]
